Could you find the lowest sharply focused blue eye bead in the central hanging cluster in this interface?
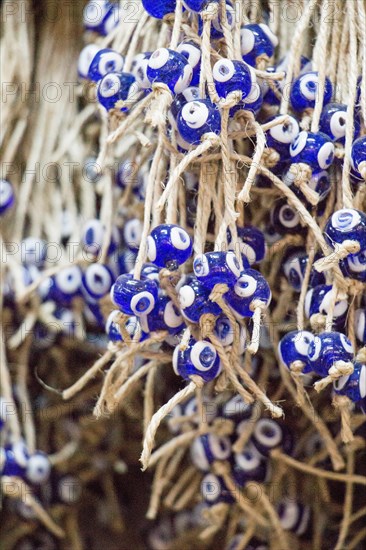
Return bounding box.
[173,338,221,382]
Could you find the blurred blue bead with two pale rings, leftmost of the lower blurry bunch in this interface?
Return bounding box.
[191,434,231,472]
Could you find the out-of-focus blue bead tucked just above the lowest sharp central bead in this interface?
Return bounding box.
[140,300,185,334]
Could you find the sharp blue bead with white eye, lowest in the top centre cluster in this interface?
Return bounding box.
[177,99,221,144]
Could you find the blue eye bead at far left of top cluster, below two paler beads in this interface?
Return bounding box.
[97,73,139,111]
